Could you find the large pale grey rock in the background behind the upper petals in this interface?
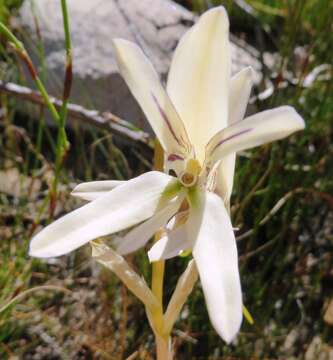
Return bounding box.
[19,0,261,129]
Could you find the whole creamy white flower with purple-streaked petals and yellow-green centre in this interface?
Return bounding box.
[30,7,304,342]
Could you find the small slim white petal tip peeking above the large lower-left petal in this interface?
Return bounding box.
[71,180,126,201]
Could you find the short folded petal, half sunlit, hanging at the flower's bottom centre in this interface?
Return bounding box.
[148,224,192,262]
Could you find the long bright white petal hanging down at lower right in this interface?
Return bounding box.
[187,192,242,342]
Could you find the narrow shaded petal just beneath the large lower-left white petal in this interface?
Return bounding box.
[115,193,185,255]
